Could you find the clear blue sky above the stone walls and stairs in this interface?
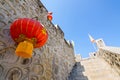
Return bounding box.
[41,0,120,58]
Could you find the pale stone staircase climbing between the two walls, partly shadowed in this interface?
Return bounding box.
[68,57,120,80]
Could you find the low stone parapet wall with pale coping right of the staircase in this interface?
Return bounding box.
[97,46,120,75]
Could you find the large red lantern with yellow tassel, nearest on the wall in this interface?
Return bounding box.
[10,18,48,58]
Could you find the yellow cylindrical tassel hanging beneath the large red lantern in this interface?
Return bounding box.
[15,41,33,58]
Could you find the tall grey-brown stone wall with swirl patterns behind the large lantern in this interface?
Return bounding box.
[0,0,75,80]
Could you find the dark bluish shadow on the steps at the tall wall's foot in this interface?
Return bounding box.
[68,62,88,80]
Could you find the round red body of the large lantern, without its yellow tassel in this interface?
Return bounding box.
[10,18,48,58]
